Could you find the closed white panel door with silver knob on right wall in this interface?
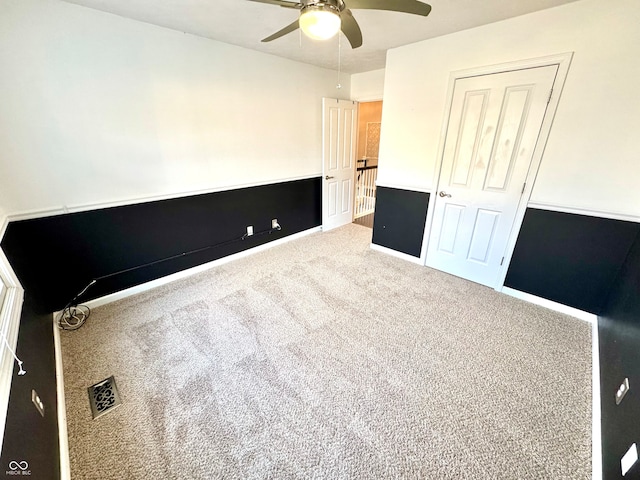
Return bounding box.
[426,65,558,287]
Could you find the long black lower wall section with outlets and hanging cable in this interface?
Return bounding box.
[2,177,322,312]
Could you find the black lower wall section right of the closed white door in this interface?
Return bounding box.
[505,208,640,315]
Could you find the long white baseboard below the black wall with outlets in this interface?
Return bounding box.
[75,227,322,312]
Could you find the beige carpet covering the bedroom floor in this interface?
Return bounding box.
[62,224,591,480]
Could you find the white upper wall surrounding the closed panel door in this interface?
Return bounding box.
[378,0,640,216]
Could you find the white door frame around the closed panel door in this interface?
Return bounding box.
[420,52,573,291]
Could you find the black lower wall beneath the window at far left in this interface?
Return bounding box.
[0,296,60,480]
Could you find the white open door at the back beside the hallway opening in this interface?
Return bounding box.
[322,98,358,230]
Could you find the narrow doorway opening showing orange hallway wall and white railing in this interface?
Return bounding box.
[353,100,382,228]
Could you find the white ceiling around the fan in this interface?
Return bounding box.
[58,0,576,73]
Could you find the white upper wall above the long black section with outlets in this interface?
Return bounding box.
[0,0,350,213]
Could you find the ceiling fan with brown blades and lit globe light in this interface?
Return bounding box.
[249,0,431,48]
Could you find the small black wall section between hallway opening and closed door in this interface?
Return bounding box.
[372,186,429,257]
